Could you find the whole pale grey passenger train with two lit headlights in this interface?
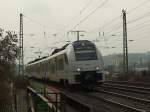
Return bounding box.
[25,40,105,88]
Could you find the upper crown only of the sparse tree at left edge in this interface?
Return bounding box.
[0,29,18,63]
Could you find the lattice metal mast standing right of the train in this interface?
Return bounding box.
[122,10,128,73]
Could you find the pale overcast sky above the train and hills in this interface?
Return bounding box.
[0,0,150,62]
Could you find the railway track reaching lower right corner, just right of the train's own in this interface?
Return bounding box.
[93,90,150,112]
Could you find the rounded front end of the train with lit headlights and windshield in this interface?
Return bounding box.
[68,40,104,86]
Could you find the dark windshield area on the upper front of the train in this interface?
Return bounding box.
[73,41,97,61]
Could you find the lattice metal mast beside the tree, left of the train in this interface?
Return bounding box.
[19,13,24,75]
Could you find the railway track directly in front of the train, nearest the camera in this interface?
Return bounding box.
[70,92,146,112]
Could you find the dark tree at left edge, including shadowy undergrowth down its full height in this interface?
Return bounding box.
[0,28,19,101]
